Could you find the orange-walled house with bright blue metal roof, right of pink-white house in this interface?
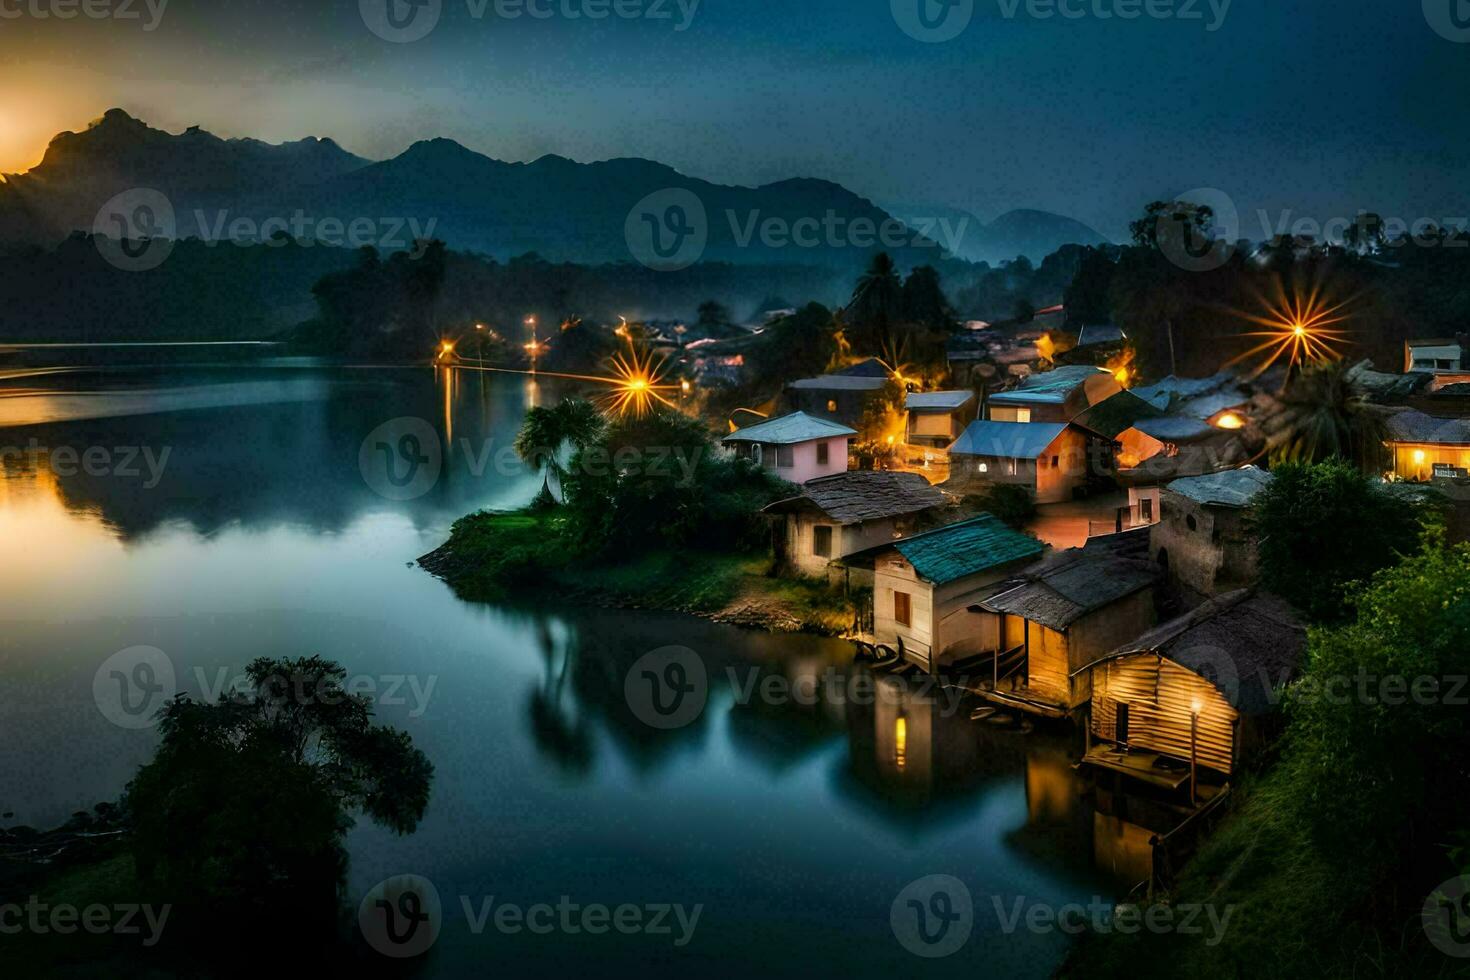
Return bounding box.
[950,422,1113,504]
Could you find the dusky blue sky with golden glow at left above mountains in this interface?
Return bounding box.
[0,0,1470,238]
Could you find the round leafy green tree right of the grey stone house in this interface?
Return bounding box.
[1250,460,1423,621]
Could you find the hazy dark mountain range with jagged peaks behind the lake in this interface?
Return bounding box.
[0,109,1103,269]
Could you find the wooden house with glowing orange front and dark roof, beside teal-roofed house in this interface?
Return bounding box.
[970,529,1160,717]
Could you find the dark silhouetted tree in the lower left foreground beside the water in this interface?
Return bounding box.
[123,657,434,942]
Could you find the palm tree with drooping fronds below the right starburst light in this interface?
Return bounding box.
[1263,361,1388,473]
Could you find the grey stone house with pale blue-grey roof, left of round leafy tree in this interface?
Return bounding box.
[1150,466,1272,599]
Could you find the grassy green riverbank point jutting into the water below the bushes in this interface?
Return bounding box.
[419,510,857,636]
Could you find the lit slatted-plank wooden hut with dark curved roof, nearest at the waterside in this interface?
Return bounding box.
[1076,589,1307,789]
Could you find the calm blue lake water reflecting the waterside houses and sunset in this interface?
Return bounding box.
[0,361,1147,977]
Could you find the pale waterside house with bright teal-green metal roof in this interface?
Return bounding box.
[845,514,1047,669]
